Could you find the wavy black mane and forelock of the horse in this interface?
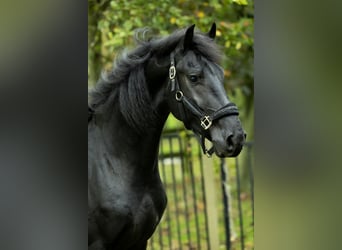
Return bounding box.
[88,26,221,133]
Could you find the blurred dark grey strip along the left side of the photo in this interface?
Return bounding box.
[0,0,88,250]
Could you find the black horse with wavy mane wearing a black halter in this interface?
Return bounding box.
[88,24,245,250]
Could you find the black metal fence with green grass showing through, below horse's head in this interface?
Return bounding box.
[148,132,254,250]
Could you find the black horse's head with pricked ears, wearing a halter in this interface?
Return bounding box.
[168,24,246,157]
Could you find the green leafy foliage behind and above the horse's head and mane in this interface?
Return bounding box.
[88,0,254,136]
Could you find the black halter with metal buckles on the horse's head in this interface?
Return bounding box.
[169,52,239,157]
